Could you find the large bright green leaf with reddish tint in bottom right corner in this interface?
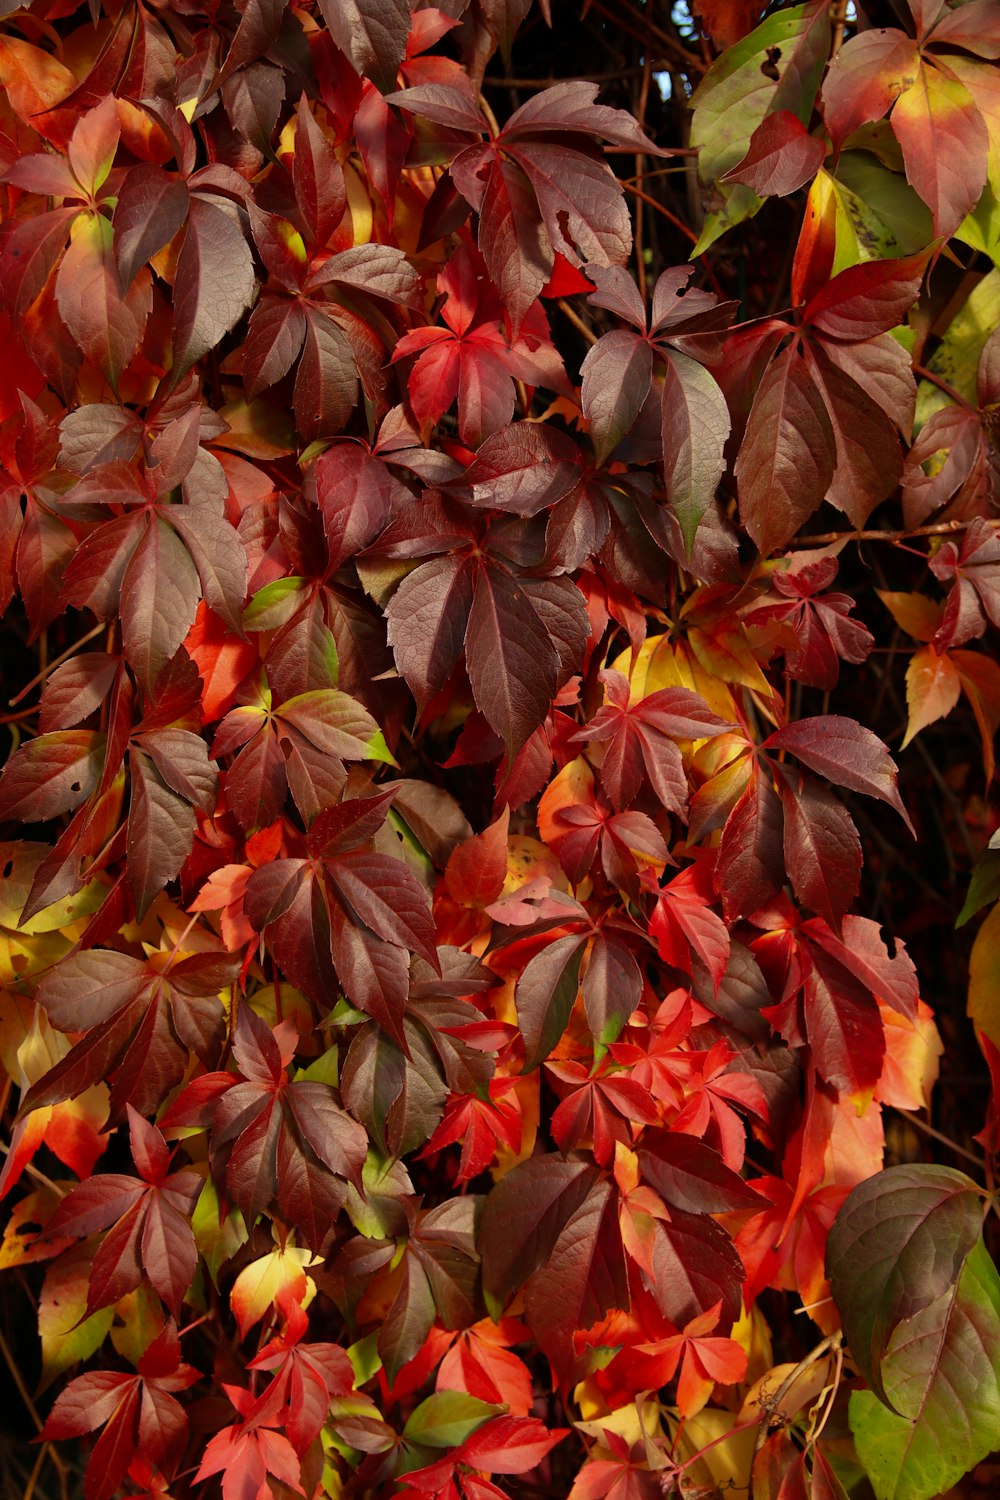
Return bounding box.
[850,1239,1000,1500]
